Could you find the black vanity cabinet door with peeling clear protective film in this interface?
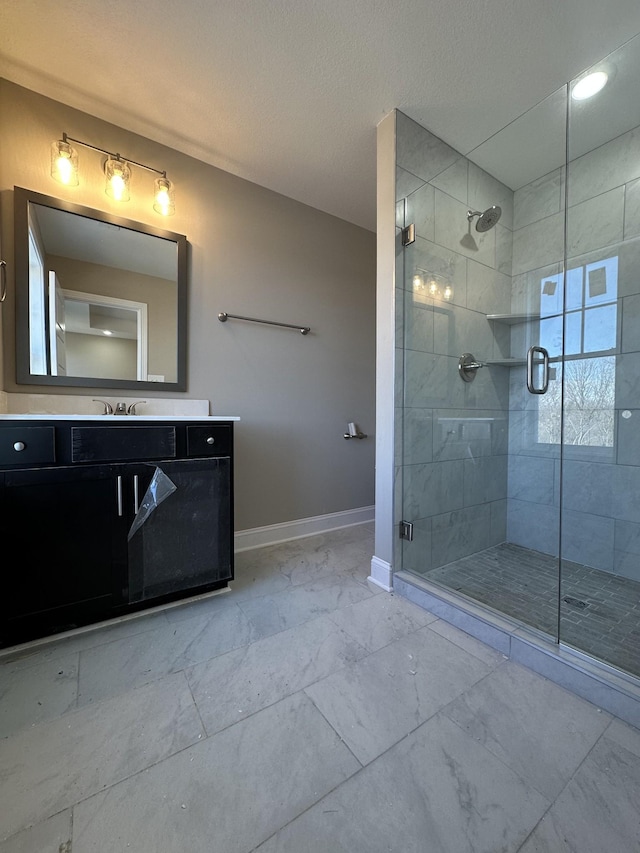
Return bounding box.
[126,456,233,603]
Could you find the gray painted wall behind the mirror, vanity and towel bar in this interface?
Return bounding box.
[0,80,376,530]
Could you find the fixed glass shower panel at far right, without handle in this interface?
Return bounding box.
[560,37,640,675]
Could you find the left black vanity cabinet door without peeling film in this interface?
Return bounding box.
[0,465,126,645]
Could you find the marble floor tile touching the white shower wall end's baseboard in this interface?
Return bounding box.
[329,584,437,652]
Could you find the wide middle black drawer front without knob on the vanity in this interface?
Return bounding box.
[71,426,176,462]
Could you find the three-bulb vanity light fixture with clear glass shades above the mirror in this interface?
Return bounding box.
[51,133,176,216]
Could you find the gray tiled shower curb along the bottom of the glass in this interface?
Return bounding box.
[393,572,640,728]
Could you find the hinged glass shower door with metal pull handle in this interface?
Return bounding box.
[397,88,566,640]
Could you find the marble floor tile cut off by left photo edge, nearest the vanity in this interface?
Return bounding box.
[0,654,78,738]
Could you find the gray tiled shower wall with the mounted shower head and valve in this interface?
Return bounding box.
[395,112,513,573]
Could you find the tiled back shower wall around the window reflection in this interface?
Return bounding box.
[507,128,640,580]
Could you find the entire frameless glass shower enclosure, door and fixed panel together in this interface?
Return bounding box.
[395,37,640,677]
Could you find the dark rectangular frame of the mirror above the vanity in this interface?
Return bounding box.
[14,187,188,391]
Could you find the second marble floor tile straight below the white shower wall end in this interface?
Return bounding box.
[305,626,491,764]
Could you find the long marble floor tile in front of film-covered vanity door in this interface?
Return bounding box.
[78,604,263,706]
